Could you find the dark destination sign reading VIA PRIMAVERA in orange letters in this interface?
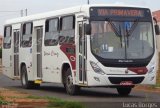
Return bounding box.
[90,7,150,18]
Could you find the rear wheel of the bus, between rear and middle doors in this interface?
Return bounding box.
[21,66,40,89]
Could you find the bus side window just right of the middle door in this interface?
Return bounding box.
[44,18,59,46]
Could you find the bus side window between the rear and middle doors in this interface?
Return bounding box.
[21,23,33,47]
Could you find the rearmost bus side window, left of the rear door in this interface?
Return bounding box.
[3,26,12,49]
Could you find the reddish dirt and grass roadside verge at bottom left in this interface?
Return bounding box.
[0,88,86,108]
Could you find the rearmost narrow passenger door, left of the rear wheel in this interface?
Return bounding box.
[13,29,20,79]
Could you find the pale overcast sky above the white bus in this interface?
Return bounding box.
[0,0,160,35]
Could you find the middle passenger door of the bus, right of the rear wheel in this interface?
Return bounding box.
[33,26,43,80]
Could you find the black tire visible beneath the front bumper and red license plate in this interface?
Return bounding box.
[117,87,132,96]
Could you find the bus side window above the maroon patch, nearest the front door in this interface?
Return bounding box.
[59,16,75,44]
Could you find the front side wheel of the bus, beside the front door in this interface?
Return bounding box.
[64,68,80,95]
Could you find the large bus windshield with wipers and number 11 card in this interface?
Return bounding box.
[91,19,154,59]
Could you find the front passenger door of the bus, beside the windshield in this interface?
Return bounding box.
[76,21,87,85]
